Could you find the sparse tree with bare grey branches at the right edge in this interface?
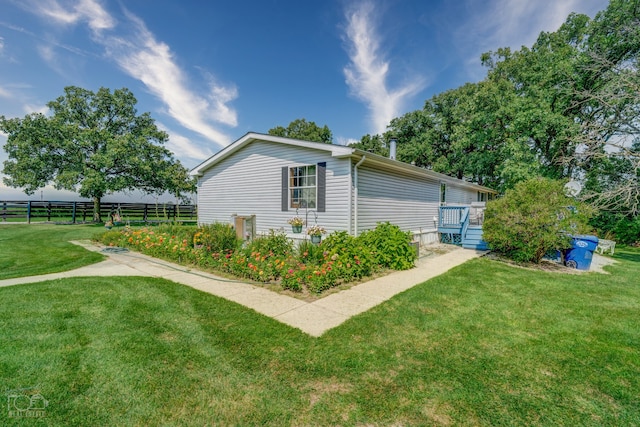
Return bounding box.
[572,0,640,214]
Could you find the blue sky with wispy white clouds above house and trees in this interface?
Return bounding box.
[0,0,608,199]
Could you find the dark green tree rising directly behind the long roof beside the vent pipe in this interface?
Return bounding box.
[389,80,517,189]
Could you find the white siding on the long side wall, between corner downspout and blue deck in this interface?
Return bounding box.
[358,163,440,233]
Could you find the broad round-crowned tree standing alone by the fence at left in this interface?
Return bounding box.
[0,86,195,221]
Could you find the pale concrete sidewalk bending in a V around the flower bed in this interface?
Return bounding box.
[0,242,485,337]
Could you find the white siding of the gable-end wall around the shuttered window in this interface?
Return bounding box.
[198,141,350,233]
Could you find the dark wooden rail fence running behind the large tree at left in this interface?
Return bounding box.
[0,201,198,224]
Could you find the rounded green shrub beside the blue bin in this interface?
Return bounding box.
[483,178,591,263]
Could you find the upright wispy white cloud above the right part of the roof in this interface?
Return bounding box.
[344,1,425,133]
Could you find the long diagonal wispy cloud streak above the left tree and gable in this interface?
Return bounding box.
[20,0,238,146]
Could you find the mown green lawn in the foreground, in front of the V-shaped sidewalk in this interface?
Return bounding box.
[0,229,640,426]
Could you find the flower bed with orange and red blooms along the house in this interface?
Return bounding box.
[100,223,415,293]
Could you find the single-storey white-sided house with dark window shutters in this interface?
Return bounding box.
[191,132,496,244]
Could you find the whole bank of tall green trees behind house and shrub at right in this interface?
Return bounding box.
[382,0,640,216]
